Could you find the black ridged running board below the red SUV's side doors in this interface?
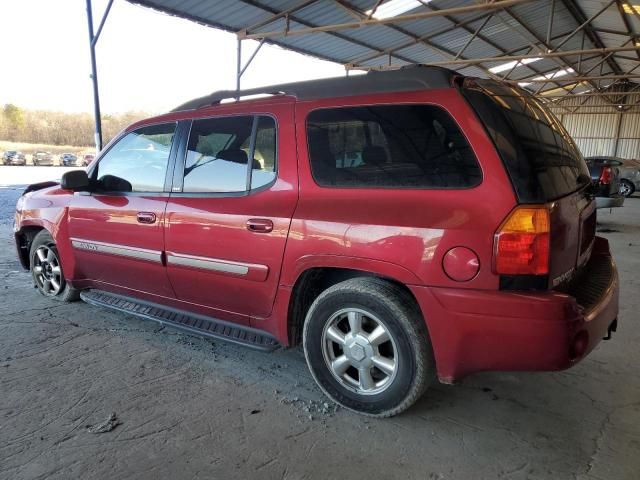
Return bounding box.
[80,290,280,351]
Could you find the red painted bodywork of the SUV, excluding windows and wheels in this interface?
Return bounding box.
[12,84,618,381]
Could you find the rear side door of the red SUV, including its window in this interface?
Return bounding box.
[165,102,297,323]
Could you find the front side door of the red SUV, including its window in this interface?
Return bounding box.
[69,123,176,297]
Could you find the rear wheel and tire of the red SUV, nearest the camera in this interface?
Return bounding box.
[303,278,435,417]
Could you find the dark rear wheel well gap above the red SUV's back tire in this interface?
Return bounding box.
[287,268,419,347]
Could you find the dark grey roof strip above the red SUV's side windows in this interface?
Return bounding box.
[173,65,459,112]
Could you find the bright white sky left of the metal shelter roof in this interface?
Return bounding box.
[0,0,344,114]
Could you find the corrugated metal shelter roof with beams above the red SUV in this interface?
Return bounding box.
[129,0,640,90]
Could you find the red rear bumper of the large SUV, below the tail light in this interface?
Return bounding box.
[412,237,619,383]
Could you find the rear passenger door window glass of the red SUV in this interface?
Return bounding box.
[182,116,276,193]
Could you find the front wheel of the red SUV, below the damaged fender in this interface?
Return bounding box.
[29,230,80,302]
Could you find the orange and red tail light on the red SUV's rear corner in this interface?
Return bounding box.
[494,206,549,275]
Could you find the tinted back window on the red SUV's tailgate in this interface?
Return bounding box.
[463,79,590,203]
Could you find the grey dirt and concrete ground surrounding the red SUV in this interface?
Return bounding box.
[0,178,640,480]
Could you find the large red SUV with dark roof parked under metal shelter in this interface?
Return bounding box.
[15,67,618,416]
